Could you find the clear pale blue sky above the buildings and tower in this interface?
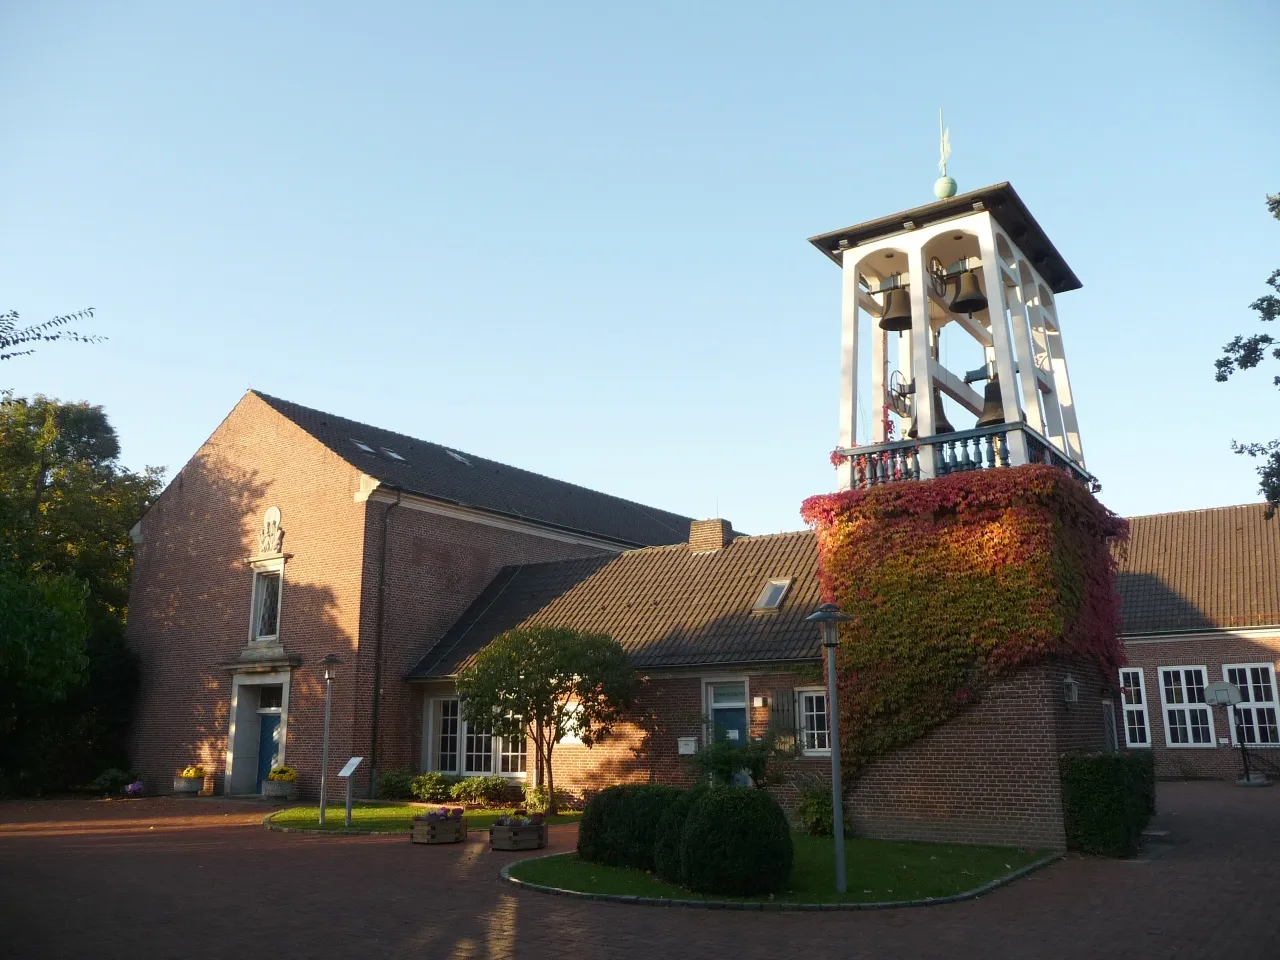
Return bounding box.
[0,0,1280,532]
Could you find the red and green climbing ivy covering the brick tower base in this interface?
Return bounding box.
[801,465,1129,776]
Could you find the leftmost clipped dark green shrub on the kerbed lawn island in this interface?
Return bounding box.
[577,783,685,870]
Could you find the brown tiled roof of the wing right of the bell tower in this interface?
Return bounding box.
[1119,503,1280,634]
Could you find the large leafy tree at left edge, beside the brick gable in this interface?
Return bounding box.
[0,393,160,792]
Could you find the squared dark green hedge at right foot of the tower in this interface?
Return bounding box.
[1060,750,1156,856]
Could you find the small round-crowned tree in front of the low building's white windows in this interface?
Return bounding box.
[458,627,636,814]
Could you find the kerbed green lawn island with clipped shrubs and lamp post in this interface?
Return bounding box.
[511,833,1046,902]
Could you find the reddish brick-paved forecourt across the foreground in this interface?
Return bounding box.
[0,783,1280,960]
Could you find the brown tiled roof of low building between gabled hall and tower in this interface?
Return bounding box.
[410,531,819,680]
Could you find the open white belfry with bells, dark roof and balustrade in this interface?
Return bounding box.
[810,181,1098,490]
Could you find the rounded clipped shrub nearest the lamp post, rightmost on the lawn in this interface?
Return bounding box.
[680,787,795,896]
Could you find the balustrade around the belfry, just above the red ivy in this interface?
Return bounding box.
[836,424,1102,493]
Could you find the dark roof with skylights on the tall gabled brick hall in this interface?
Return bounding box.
[252,390,690,547]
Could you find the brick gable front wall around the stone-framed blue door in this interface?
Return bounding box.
[128,394,364,792]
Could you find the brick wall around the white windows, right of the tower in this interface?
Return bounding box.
[1117,631,1280,780]
